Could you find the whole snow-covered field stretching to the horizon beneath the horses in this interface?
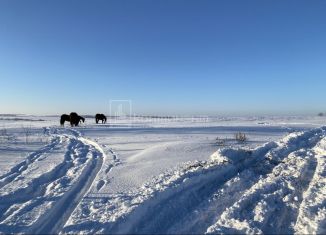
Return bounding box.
[0,115,326,234]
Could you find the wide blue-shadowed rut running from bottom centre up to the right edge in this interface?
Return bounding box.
[110,129,324,234]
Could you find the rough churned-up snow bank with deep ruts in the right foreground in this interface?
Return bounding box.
[62,128,326,234]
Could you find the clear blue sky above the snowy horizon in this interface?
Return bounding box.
[0,0,326,115]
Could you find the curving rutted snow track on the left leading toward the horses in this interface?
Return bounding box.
[0,129,105,234]
